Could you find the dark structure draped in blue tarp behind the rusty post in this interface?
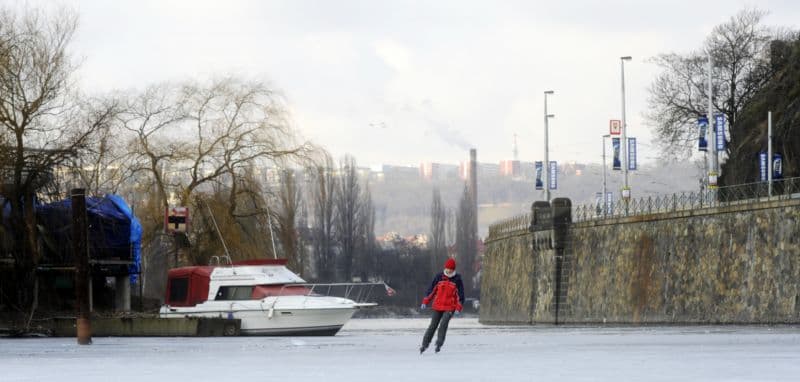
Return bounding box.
[0,195,142,311]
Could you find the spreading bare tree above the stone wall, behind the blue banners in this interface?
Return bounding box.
[646,9,788,157]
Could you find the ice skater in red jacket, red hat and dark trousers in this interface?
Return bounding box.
[419,258,464,354]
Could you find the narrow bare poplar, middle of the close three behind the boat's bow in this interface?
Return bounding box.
[335,155,363,280]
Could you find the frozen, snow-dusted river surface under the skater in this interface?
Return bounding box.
[0,318,800,382]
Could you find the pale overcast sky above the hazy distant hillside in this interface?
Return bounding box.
[9,0,800,166]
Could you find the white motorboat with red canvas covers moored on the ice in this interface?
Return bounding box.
[159,259,393,336]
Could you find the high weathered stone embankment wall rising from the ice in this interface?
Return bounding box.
[480,199,800,324]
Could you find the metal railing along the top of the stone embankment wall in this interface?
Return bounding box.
[489,177,800,238]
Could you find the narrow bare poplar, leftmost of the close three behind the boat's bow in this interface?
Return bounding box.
[310,153,338,281]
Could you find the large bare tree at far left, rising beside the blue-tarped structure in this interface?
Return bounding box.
[0,7,114,316]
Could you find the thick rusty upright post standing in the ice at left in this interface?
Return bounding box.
[71,188,92,345]
